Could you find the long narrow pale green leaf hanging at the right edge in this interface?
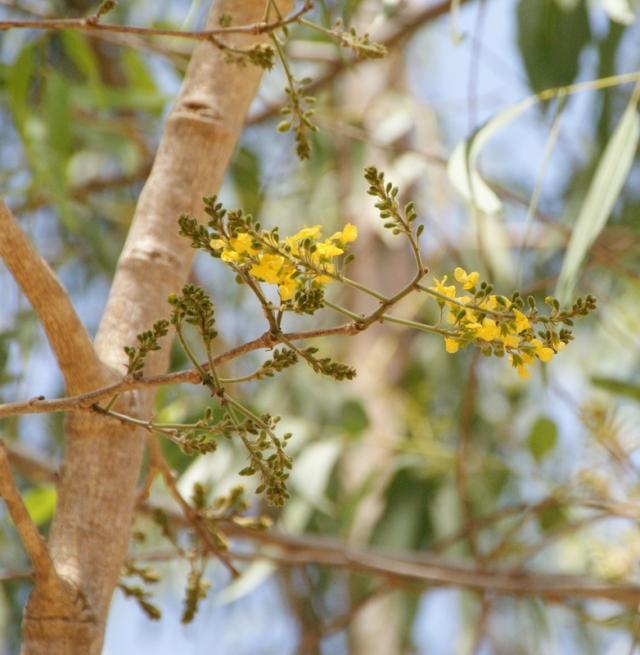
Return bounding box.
[555,85,640,303]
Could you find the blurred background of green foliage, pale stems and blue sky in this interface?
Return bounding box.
[0,0,640,655]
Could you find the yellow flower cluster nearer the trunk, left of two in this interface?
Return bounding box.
[209,223,358,301]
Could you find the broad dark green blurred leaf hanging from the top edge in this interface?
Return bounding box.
[517,0,591,92]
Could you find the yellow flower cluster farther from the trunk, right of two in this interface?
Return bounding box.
[429,268,565,379]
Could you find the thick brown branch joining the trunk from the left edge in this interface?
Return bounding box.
[0,199,105,393]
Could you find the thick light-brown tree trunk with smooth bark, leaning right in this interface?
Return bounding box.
[23,0,290,655]
